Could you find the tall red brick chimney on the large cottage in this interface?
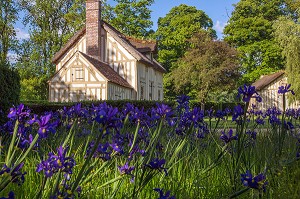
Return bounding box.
[85,0,101,60]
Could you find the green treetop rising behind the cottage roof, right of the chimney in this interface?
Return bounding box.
[109,0,154,38]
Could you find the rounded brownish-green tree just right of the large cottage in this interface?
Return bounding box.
[171,32,240,101]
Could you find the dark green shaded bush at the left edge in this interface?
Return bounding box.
[0,65,20,116]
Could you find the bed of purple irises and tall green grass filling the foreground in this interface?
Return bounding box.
[0,89,300,199]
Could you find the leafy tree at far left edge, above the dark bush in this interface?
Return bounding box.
[0,0,18,65]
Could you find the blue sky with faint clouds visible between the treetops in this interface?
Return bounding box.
[15,0,239,39]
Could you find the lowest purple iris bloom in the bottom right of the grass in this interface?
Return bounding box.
[241,170,268,191]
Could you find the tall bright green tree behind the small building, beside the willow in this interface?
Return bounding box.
[224,0,289,83]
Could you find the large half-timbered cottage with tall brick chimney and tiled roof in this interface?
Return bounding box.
[48,0,165,102]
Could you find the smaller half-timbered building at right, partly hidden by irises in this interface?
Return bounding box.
[250,71,300,110]
